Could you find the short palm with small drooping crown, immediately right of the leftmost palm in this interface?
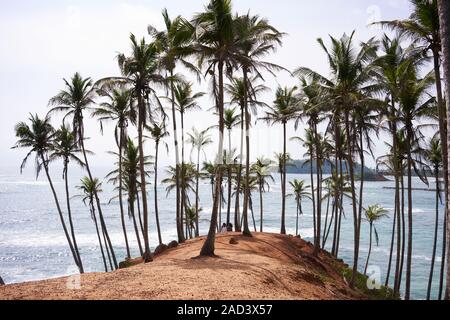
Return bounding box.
[49,125,84,273]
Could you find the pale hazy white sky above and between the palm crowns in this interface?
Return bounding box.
[0,0,410,172]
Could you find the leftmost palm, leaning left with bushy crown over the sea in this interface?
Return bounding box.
[13,114,82,272]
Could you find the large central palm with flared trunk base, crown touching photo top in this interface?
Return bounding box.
[193,0,236,256]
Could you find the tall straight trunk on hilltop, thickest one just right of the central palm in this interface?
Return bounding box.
[243,68,252,237]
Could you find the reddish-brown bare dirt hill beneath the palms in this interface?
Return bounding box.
[0,234,365,300]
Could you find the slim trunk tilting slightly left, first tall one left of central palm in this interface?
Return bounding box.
[170,70,186,243]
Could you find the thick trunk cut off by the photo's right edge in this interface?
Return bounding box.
[438,0,450,300]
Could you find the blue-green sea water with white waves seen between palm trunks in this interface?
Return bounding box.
[0,168,443,299]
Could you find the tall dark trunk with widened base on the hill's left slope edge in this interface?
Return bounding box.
[138,92,153,262]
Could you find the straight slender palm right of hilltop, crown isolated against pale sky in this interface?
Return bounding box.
[262,87,299,234]
